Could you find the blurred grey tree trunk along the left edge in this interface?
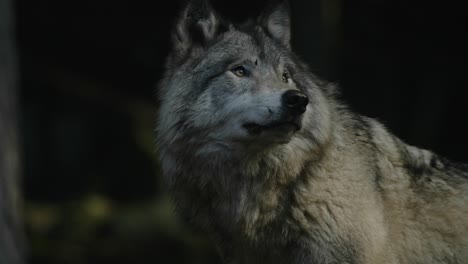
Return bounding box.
[0,0,23,264]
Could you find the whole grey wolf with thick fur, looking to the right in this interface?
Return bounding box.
[157,1,468,264]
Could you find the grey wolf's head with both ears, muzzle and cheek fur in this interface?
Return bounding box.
[158,0,330,159]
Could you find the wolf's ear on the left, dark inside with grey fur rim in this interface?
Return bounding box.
[172,0,220,54]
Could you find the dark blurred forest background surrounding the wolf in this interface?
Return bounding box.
[0,0,468,264]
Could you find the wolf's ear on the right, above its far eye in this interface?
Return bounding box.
[259,0,291,48]
